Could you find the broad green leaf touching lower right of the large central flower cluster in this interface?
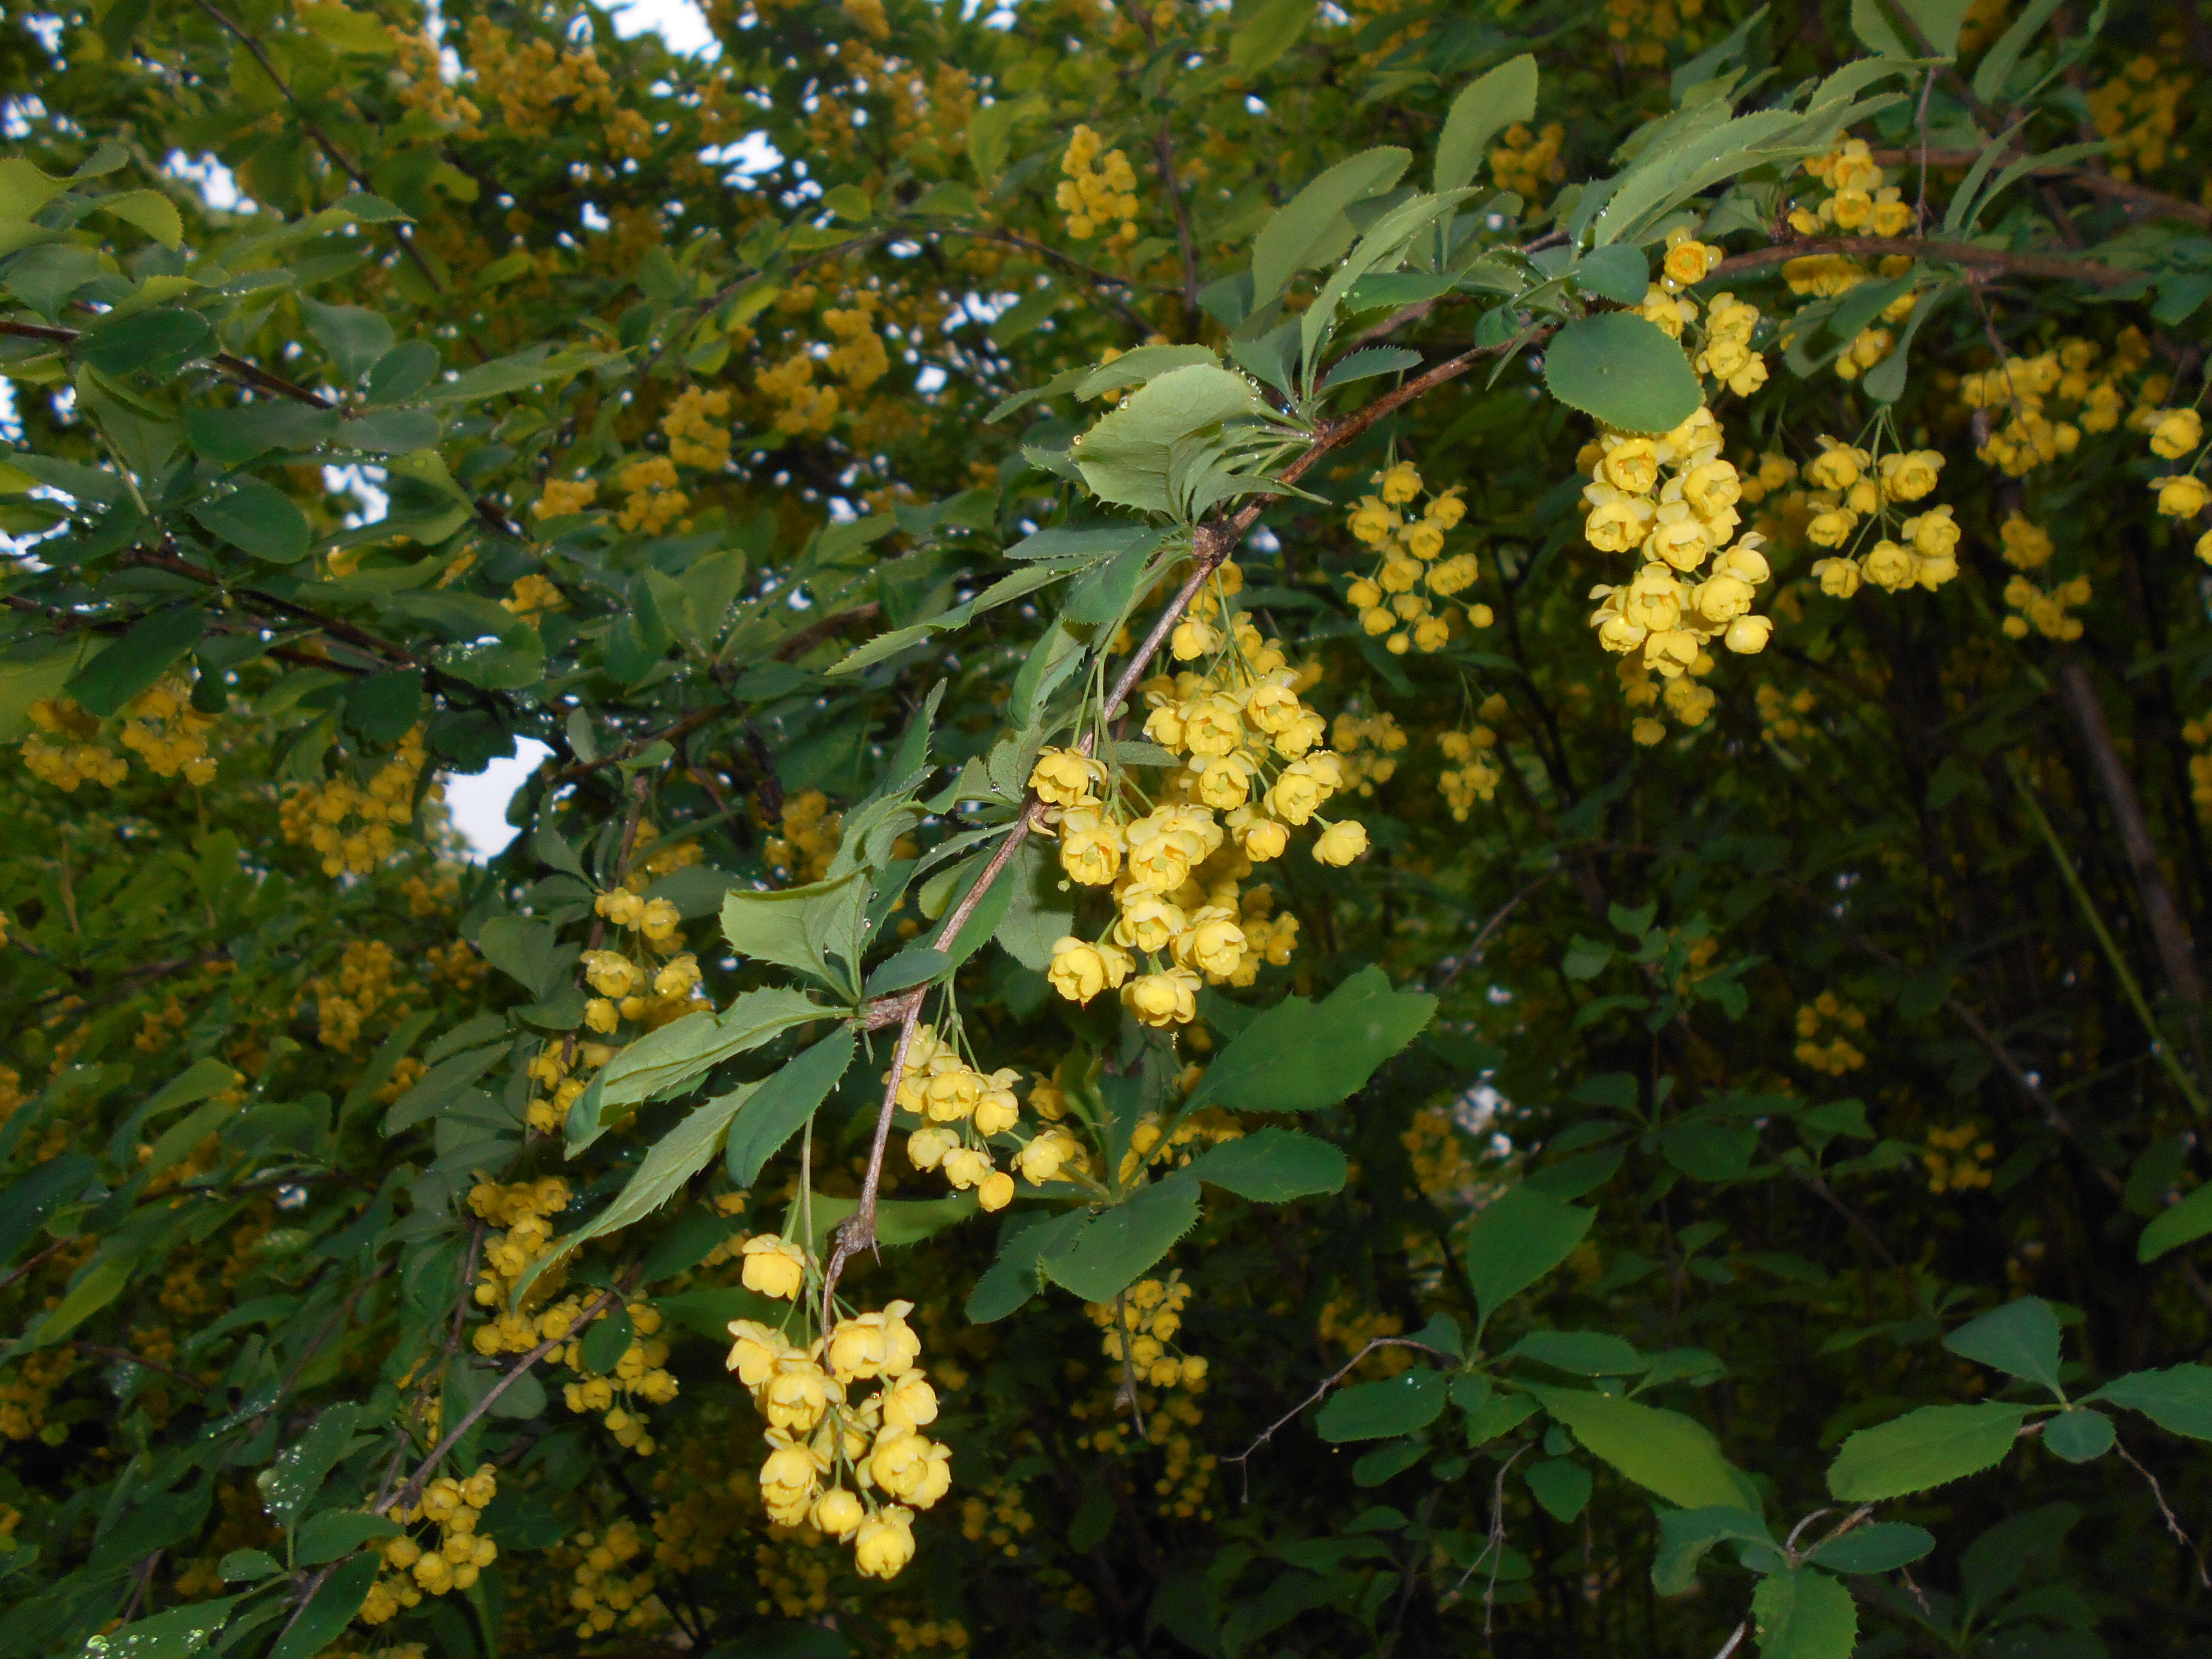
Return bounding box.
[1190,966,1436,1112]
